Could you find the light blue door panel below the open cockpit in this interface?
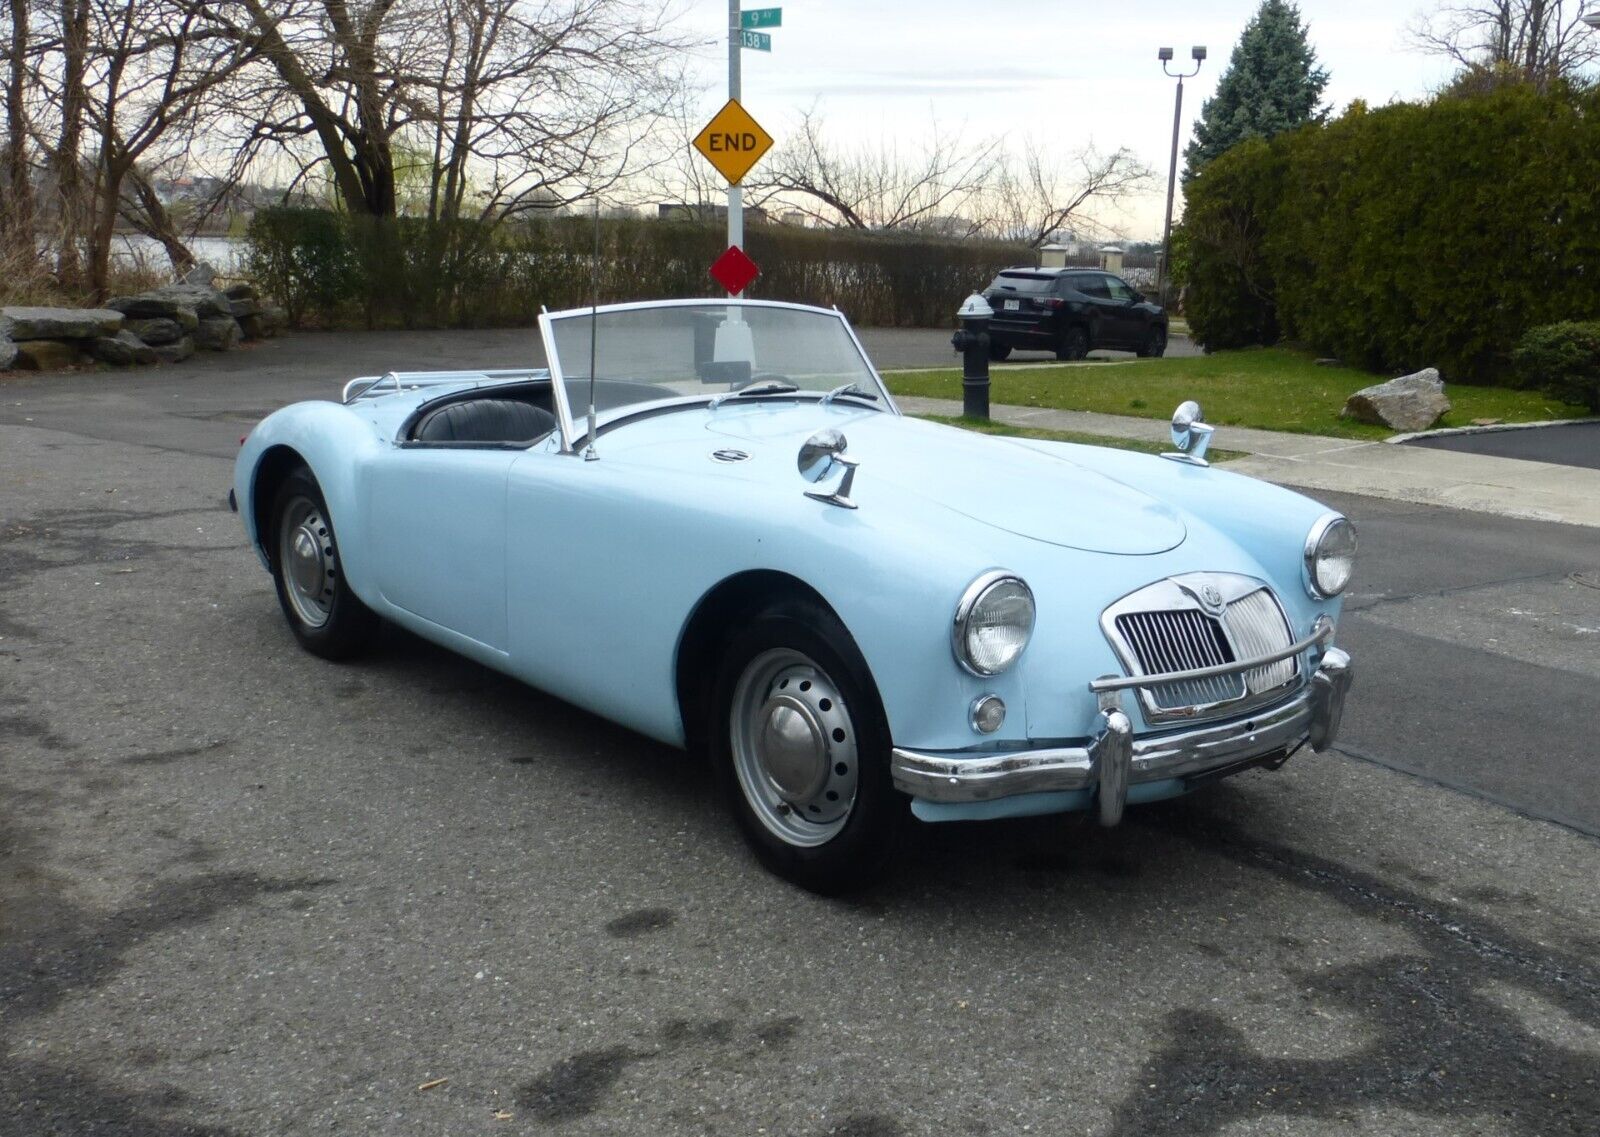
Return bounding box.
[366,445,523,652]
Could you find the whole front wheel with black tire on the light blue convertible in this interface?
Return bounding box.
[709,603,909,896]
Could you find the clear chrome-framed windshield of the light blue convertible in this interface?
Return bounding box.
[550,304,883,419]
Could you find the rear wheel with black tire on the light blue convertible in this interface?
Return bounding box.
[272,465,378,659]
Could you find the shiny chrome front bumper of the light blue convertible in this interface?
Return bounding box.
[890,681,1324,805]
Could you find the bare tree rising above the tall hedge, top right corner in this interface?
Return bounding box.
[1411,0,1600,85]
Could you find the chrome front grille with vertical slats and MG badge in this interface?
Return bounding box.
[1101,572,1301,721]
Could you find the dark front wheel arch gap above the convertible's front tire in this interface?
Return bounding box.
[674,569,877,764]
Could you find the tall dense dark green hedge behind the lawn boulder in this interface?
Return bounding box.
[1184,86,1600,382]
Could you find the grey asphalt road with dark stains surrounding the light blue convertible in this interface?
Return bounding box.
[0,334,1600,1137]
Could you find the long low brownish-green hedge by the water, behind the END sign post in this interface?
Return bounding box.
[246,208,1034,328]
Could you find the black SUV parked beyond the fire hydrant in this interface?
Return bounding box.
[984,269,1166,360]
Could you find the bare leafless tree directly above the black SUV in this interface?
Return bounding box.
[981,139,1155,246]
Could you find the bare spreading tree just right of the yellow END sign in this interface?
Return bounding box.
[746,107,1005,229]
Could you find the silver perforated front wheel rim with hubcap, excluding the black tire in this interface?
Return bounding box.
[728,648,858,846]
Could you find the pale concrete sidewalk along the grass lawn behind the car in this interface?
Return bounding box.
[894,397,1600,528]
